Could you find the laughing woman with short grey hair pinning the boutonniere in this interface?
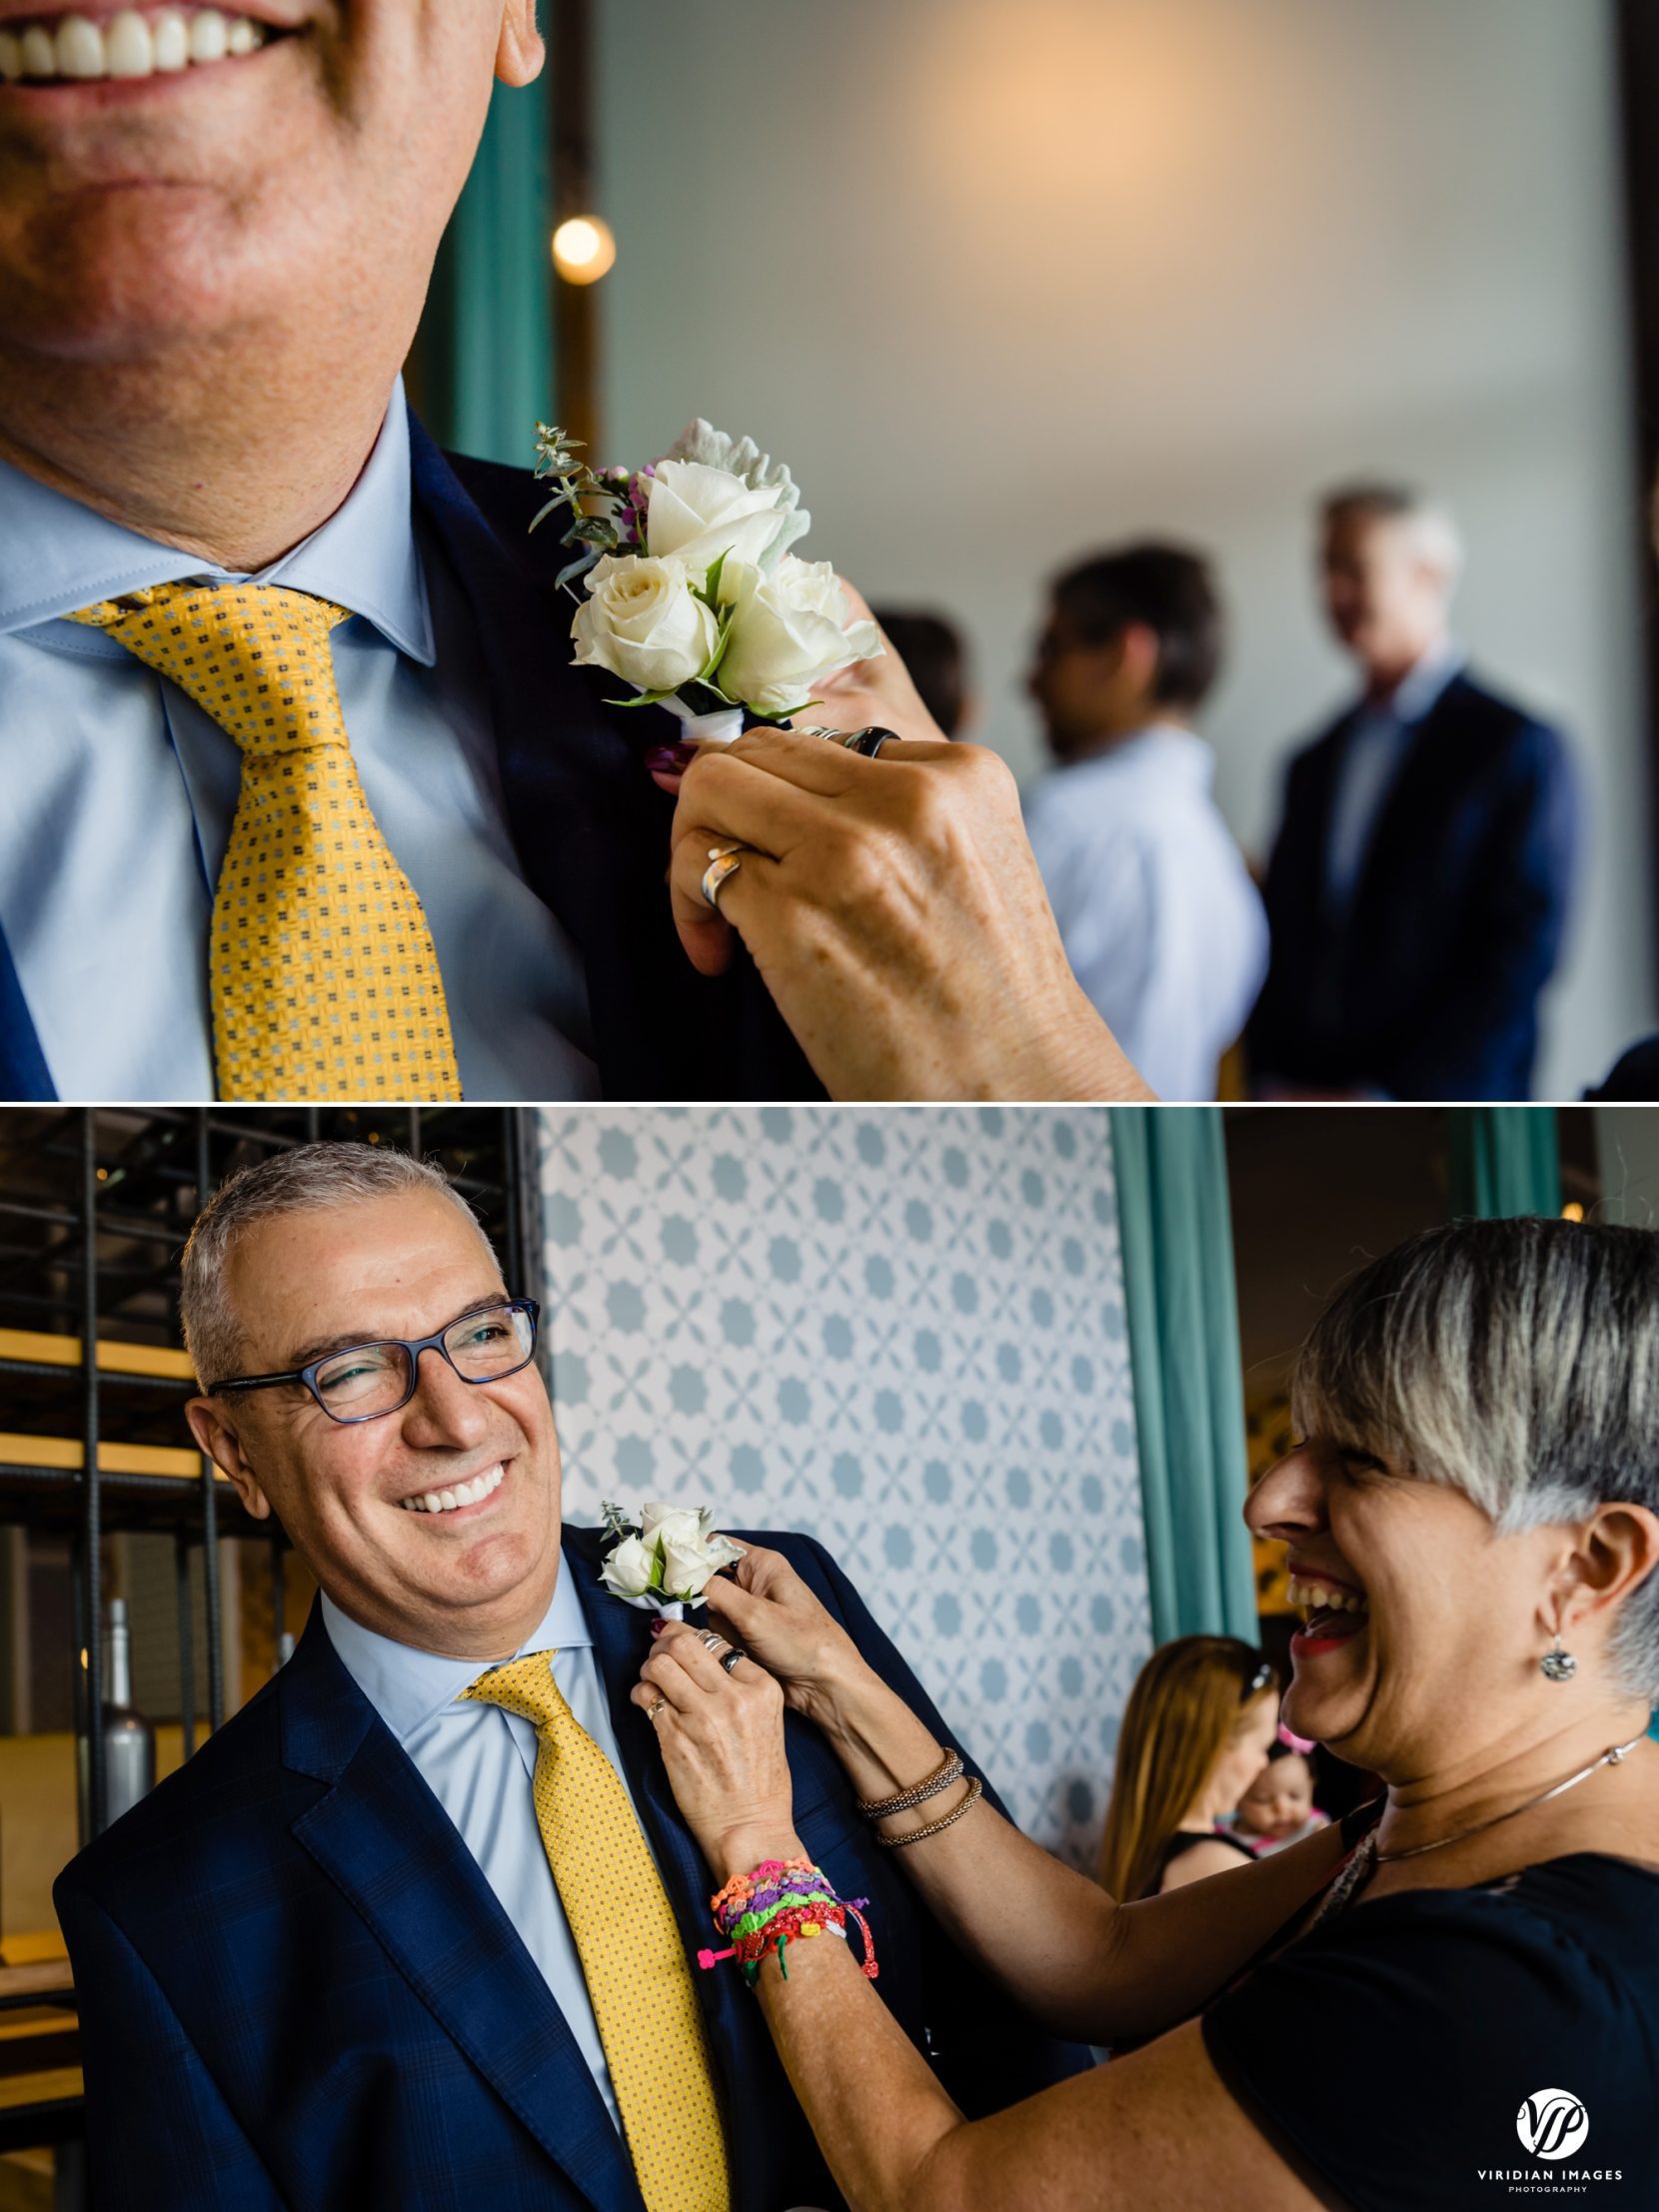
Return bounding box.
[635,1221,1659,2212]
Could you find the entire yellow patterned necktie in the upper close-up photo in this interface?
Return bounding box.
[71,583,460,1099]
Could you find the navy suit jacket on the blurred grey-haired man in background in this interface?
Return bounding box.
[1247,676,1577,1099]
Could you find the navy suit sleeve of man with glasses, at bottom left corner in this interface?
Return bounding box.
[53,1882,283,2212]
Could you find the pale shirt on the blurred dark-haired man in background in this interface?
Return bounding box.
[1026,723,1267,1099]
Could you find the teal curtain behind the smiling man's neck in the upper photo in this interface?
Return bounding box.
[409,80,556,467]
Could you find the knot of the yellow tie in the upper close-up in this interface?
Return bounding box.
[71,583,350,752]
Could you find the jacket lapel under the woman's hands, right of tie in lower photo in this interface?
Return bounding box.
[564,1527,781,2208]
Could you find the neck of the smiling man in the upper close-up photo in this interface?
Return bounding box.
[0,327,396,572]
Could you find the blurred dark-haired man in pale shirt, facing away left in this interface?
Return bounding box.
[1026,545,1267,1099]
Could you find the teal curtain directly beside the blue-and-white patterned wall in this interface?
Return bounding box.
[1110,1106,1258,1644]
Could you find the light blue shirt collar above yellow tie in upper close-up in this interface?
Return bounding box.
[0,379,436,665]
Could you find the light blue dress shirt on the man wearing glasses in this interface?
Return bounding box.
[321,1558,644,2130]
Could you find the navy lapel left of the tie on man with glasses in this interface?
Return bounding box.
[279,1613,642,2212]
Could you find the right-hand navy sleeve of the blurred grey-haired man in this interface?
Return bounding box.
[1391,721,1577,1099]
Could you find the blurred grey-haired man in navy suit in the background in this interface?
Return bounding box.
[1250,485,1577,1099]
